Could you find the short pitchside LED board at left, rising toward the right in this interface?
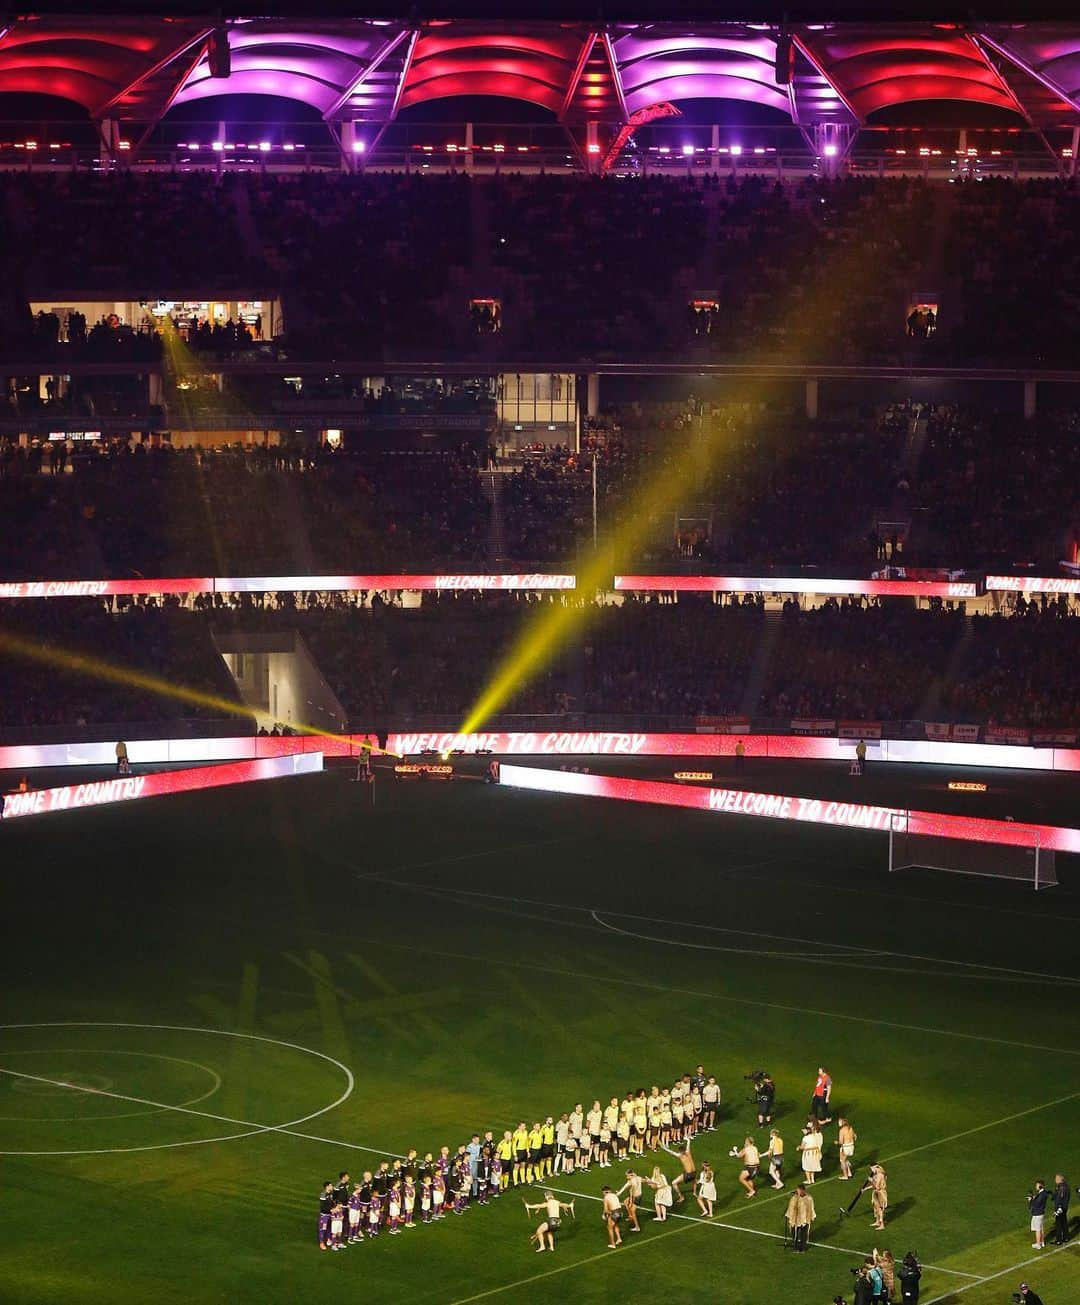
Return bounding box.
[4,752,322,820]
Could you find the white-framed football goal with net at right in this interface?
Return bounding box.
[888,812,1058,891]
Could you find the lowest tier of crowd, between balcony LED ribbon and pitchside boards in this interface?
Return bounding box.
[0,591,1080,731]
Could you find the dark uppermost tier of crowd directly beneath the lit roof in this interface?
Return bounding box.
[0,171,1080,365]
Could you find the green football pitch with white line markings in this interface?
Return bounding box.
[0,773,1080,1305]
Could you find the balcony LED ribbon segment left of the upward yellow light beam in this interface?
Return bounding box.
[0,573,575,598]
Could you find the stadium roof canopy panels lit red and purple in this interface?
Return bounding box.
[0,13,1080,128]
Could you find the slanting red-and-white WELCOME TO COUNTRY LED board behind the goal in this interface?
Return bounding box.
[501,763,1080,852]
